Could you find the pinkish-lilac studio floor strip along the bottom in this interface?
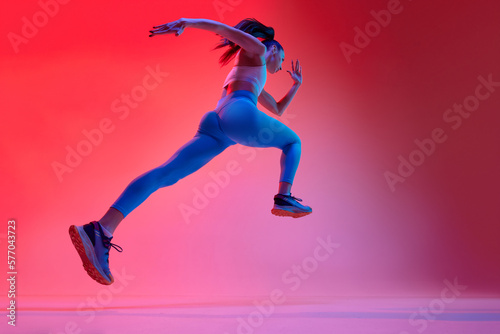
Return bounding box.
[0,296,500,334]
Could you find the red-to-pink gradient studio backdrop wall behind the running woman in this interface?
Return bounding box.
[0,0,500,306]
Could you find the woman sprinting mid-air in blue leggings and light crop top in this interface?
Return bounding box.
[69,19,312,285]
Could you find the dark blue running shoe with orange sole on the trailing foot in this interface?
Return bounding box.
[69,222,123,285]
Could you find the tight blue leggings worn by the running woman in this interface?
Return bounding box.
[111,90,301,217]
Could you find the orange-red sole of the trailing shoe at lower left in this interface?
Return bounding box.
[69,225,113,285]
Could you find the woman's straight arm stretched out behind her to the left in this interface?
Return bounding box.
[149,18,266,56]
